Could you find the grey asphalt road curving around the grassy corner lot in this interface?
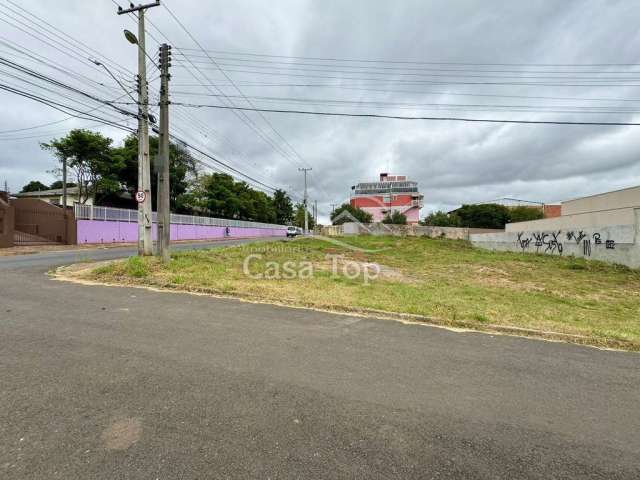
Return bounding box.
[0,245,640,480]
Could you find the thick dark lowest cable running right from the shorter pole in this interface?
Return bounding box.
[172,103,640,126]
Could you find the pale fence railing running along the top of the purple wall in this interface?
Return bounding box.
[74,203,287,230]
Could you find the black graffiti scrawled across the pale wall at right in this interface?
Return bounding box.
[516,230,616,257]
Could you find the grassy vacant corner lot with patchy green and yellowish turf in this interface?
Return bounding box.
[79,237,640,350]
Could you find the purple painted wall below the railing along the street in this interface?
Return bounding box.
[77,220,287,243]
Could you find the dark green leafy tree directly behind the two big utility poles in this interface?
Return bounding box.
[112,135,198,213]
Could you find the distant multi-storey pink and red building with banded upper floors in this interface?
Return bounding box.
[351,173,424,224]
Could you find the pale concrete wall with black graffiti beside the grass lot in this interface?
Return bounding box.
[470,209,640,268]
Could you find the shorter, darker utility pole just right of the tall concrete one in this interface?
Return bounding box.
[156,43,171,262]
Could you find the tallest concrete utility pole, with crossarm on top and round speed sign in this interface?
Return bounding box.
[118,0,160,255]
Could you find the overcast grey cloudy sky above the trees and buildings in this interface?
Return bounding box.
[0,0,640,223]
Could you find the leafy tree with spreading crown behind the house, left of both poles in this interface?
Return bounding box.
[40,129,122,203]
